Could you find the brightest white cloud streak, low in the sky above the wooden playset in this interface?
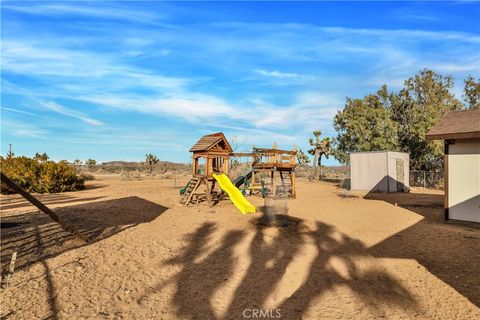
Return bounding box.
[72,87,343,132]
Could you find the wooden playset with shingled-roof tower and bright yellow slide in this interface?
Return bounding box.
[180,132,297,213]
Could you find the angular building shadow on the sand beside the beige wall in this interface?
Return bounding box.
[365,193,480,307]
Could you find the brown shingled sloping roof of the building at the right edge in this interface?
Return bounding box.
[426,109,480,140]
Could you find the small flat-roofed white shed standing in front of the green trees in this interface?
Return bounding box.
[350,151,410,192]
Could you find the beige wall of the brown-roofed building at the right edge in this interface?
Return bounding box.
[448,139,480,222]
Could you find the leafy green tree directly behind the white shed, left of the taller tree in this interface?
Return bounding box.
[333,90,399,163]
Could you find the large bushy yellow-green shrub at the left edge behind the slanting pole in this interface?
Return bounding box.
[0,156,85,194]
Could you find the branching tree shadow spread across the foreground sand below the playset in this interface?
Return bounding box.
[145,221,417,319]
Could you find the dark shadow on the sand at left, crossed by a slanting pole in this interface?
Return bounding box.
[1,197,168,270]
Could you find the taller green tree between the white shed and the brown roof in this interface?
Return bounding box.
[390,69,462,171]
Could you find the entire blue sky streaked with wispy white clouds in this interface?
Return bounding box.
[1,1,480,164]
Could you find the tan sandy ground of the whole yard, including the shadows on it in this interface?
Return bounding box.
[1,177,480,319]
